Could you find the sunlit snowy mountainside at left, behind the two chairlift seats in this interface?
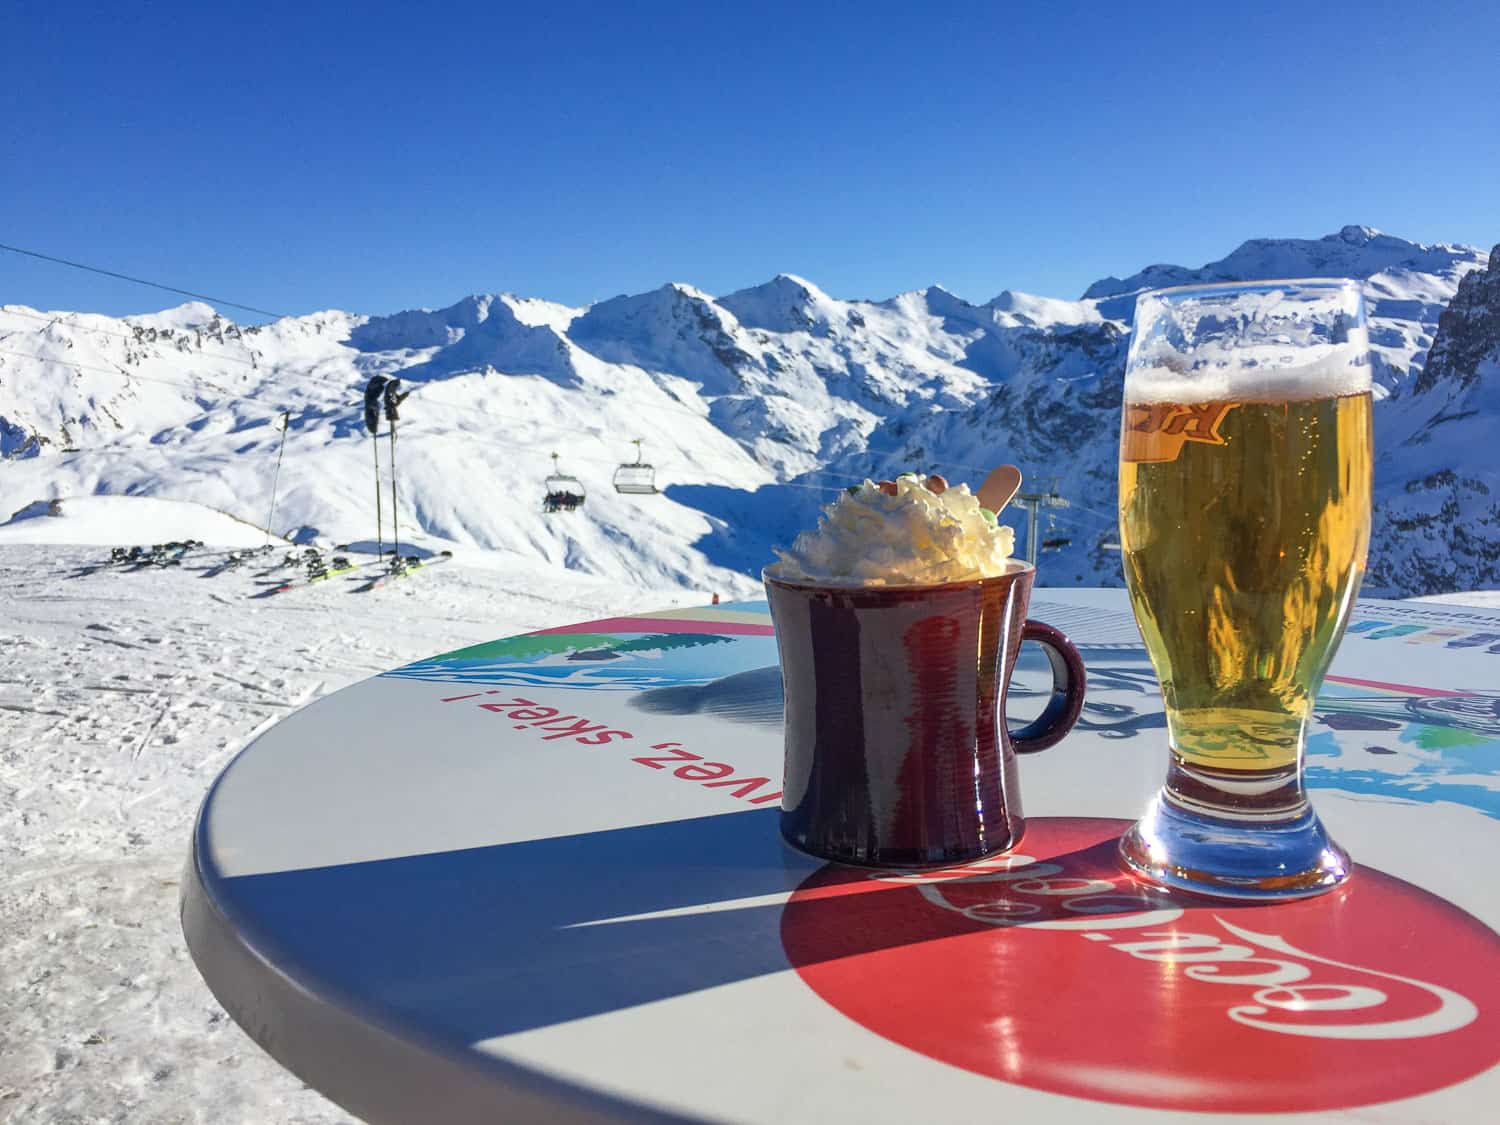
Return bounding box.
[0,297,771,594]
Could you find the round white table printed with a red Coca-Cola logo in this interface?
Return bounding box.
[182,590,1500,1122]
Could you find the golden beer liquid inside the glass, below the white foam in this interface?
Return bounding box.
[1119,392,1371,780]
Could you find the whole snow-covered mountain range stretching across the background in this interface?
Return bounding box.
[0,227,1500,594]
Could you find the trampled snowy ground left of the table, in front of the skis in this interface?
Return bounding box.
[0,546,690,1125]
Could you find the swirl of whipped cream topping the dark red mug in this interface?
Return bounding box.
[767,476,1016,587]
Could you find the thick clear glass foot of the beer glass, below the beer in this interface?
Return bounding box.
[1119,756,1352,902]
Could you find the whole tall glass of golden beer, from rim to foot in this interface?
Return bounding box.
[1119,279,1371,900]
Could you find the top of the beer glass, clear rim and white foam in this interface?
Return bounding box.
[1125,279,1371,402]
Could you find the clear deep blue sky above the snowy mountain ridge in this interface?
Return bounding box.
[0,0,1500,320]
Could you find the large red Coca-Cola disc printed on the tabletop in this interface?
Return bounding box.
[782,818,1500,1113]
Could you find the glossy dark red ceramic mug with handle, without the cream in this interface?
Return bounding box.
[764,563,1085,867]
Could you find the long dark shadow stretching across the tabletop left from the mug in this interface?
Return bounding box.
[216,809,1134,1043]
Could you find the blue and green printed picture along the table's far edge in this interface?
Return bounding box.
[386,600,1500,819]
